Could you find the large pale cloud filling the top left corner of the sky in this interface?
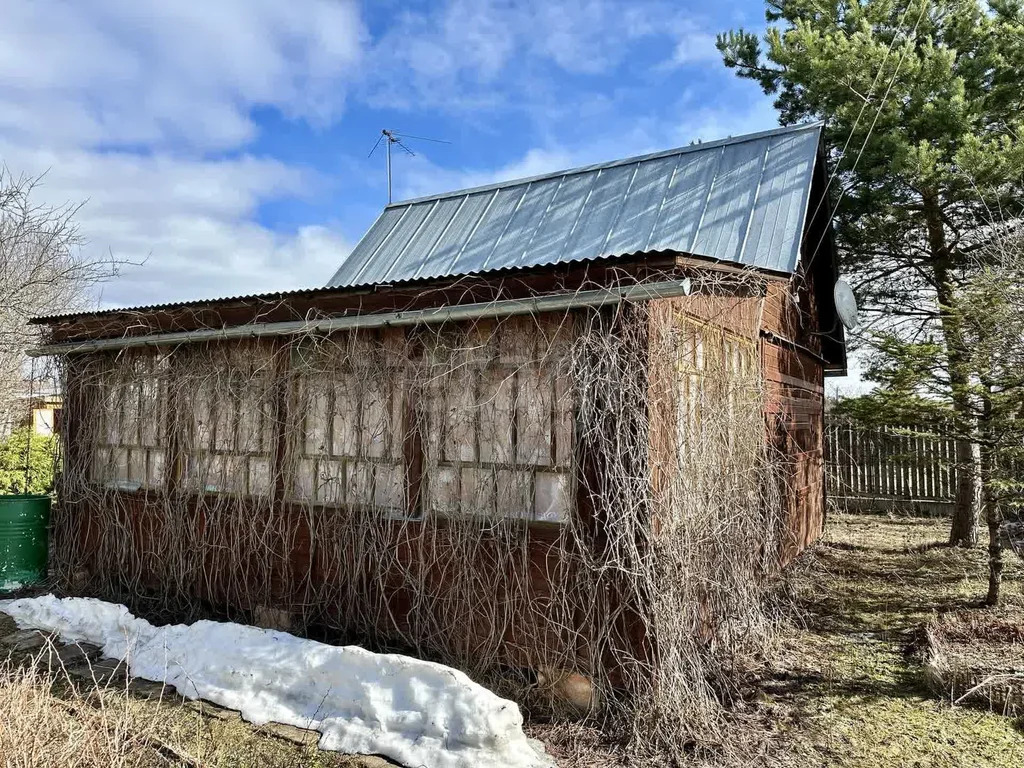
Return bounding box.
[0,0,365,148]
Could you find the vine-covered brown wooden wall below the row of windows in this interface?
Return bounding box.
[55,492,581,670]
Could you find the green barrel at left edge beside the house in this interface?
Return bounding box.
[0,495,50,592]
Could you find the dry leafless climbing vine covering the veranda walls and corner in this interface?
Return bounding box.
[44,272,782,756]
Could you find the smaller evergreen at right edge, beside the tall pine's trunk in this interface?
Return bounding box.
[833,237,1024,605]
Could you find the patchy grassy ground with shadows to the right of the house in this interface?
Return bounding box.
[761,515,1024,768]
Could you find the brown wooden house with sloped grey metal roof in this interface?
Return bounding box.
[29,124,845,700]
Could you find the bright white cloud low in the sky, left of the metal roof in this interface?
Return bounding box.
[0,143,349,305]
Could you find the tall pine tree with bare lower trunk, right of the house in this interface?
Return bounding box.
[718,0,1024,546]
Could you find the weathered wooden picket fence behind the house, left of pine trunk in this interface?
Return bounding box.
[824,422,956,514]
